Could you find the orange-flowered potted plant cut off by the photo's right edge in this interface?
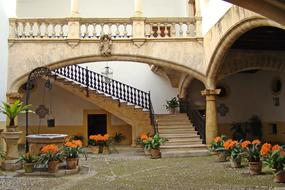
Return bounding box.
[260,143,285,183]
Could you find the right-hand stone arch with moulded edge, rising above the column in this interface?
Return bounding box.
[205,6,285,88]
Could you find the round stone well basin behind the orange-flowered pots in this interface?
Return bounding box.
[26,134,67,155]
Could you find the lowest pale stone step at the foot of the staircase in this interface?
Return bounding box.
[161,149,210,158]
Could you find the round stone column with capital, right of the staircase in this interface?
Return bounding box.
[201,89,221,144]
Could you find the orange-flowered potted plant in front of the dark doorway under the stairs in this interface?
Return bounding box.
[89,134,109,154]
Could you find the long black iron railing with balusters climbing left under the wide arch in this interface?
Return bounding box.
[53,65,158,132]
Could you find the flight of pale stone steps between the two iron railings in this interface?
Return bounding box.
[157,114,209,157]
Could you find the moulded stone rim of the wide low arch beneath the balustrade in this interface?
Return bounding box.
[7,55,206,94]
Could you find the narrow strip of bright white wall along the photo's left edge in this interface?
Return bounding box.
[0,0,15,123]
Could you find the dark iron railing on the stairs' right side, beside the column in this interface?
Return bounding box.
[180,100,206,144]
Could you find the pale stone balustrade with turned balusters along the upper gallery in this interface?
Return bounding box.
[9,17,200,40]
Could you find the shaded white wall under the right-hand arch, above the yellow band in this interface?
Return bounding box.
[217,71,285,123]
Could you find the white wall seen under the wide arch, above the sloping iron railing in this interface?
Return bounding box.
[80,61,178,113]
